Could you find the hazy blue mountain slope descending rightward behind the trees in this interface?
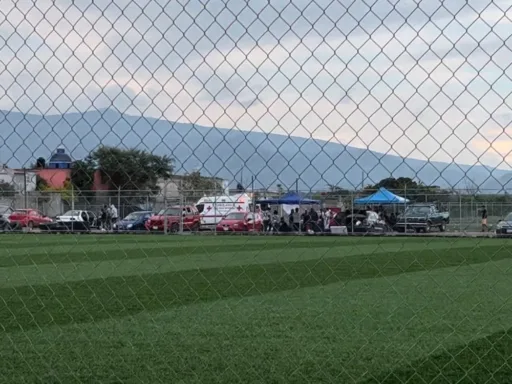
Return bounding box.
[0,109,512,190]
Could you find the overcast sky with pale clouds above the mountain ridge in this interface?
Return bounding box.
[0,0,512,167]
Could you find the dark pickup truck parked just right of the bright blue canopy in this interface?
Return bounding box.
[394,204,450,233]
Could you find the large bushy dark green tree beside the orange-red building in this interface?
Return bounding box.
[88,147,173,195]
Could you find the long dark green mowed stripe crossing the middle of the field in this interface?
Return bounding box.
[0,238,511,332]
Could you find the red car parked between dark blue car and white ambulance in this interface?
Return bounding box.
[145,205,201,233]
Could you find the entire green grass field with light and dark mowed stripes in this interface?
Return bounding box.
[0,235,512,383]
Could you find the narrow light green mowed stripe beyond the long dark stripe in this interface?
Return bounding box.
[0,241,500,288]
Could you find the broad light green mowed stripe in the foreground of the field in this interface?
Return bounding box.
[5,255,512,384]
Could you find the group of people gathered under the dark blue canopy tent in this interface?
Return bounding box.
[263,208,332,233]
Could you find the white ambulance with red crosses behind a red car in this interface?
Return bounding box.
[196,193,259,229]
